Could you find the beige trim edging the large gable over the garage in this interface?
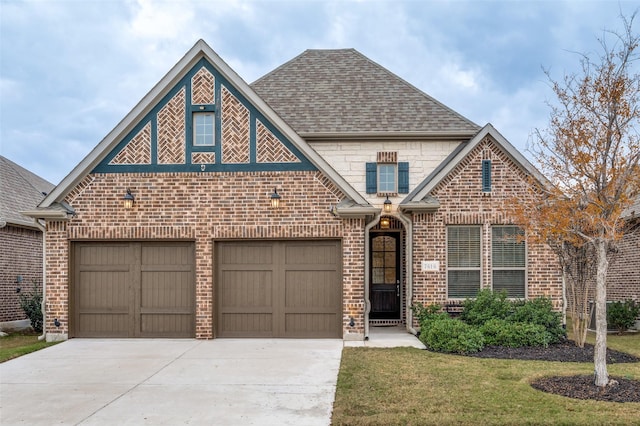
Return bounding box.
[36,40,369,211]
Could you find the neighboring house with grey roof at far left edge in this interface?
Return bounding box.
[0,156,54,328]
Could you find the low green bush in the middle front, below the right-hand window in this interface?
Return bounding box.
[480,318,551,348]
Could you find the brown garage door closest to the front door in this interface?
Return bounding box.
[216,241,342,338]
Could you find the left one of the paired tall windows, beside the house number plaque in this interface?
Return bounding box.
[447,226,481,299]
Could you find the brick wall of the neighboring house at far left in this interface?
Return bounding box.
[0,225,42,322]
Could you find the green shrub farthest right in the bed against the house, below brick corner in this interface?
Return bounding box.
[508,297,567,343]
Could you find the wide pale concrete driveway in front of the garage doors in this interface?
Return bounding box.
[0,339,343,425]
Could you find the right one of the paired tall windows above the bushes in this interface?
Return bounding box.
[491,226,526,299]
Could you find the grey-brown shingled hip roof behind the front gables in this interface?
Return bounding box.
[251,49,480,139]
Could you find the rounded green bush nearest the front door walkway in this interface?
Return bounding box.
[420,314,484,354]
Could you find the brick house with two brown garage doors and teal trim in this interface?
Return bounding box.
[23,40,562,340]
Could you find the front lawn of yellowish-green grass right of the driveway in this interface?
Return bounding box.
[332,333,640,425]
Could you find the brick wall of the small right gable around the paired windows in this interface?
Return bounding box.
[413,138,562,326]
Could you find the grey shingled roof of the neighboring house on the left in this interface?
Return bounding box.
[0,156,55,228]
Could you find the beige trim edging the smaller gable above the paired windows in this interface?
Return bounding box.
[399,124,550,212]
